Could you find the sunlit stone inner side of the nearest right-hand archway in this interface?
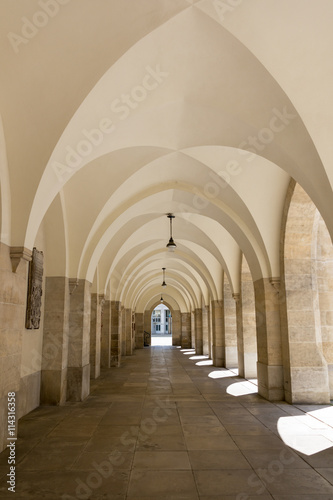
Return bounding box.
[280,180,331,404]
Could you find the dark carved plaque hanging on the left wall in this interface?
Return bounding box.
[25,248,44,330]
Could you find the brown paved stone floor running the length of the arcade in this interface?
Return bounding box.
[0,347,333,500]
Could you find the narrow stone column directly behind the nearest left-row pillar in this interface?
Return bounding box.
[90,293,104,379]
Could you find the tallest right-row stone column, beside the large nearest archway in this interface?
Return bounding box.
[254,278,282,401]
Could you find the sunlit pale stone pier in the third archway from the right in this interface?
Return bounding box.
[223,278,238,368]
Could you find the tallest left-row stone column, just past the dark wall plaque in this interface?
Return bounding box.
[67,279,91,401]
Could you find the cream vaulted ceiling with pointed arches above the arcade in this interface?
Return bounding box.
[0,0,333,311]
